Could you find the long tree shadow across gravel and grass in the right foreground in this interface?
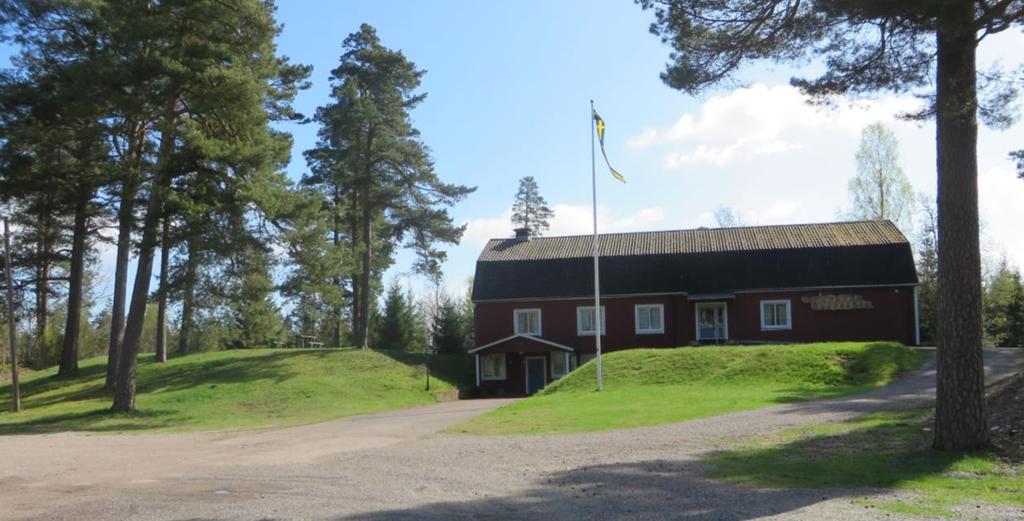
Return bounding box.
[327,410,1024,521]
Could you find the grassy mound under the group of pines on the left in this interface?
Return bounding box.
[0,349,472,435]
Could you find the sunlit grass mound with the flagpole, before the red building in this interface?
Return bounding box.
[450,343,926,435]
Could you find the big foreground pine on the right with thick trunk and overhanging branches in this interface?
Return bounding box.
[638,0,1024,449]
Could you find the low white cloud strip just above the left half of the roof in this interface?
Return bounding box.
[463,204,666,246]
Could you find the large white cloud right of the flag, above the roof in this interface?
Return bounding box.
[628,84,918,170]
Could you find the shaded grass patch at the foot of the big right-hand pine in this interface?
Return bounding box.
[710,410,1024,517]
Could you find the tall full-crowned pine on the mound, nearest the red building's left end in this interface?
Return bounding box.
[306,25,474,348]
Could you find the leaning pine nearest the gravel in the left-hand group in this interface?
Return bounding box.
[113,0,308,411]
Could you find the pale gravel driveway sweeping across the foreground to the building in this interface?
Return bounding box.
[0,350,1024,521]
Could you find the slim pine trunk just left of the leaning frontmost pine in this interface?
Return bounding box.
[105,180,136,389]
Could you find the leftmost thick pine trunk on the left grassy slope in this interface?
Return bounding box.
[57,192,89,377]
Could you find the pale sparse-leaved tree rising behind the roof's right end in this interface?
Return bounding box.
[850,123,914,231]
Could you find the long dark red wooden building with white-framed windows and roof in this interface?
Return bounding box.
[470,221,919,395]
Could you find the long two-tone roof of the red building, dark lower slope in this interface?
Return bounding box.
[473,221,918,301]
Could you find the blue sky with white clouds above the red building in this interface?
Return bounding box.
[2,0,1024,305]
